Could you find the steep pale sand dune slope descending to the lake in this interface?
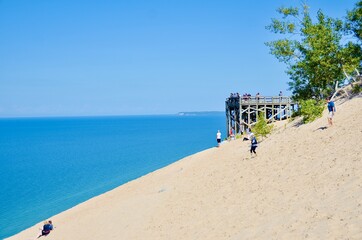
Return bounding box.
[8,98,362,240]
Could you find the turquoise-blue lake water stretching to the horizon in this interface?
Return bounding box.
[0,113,225,239]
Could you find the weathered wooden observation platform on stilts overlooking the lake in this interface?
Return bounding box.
[225,96,296,137]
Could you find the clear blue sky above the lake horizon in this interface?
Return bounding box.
[0,0,357,117]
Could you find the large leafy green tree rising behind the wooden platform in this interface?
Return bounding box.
[266,5,361,100]
